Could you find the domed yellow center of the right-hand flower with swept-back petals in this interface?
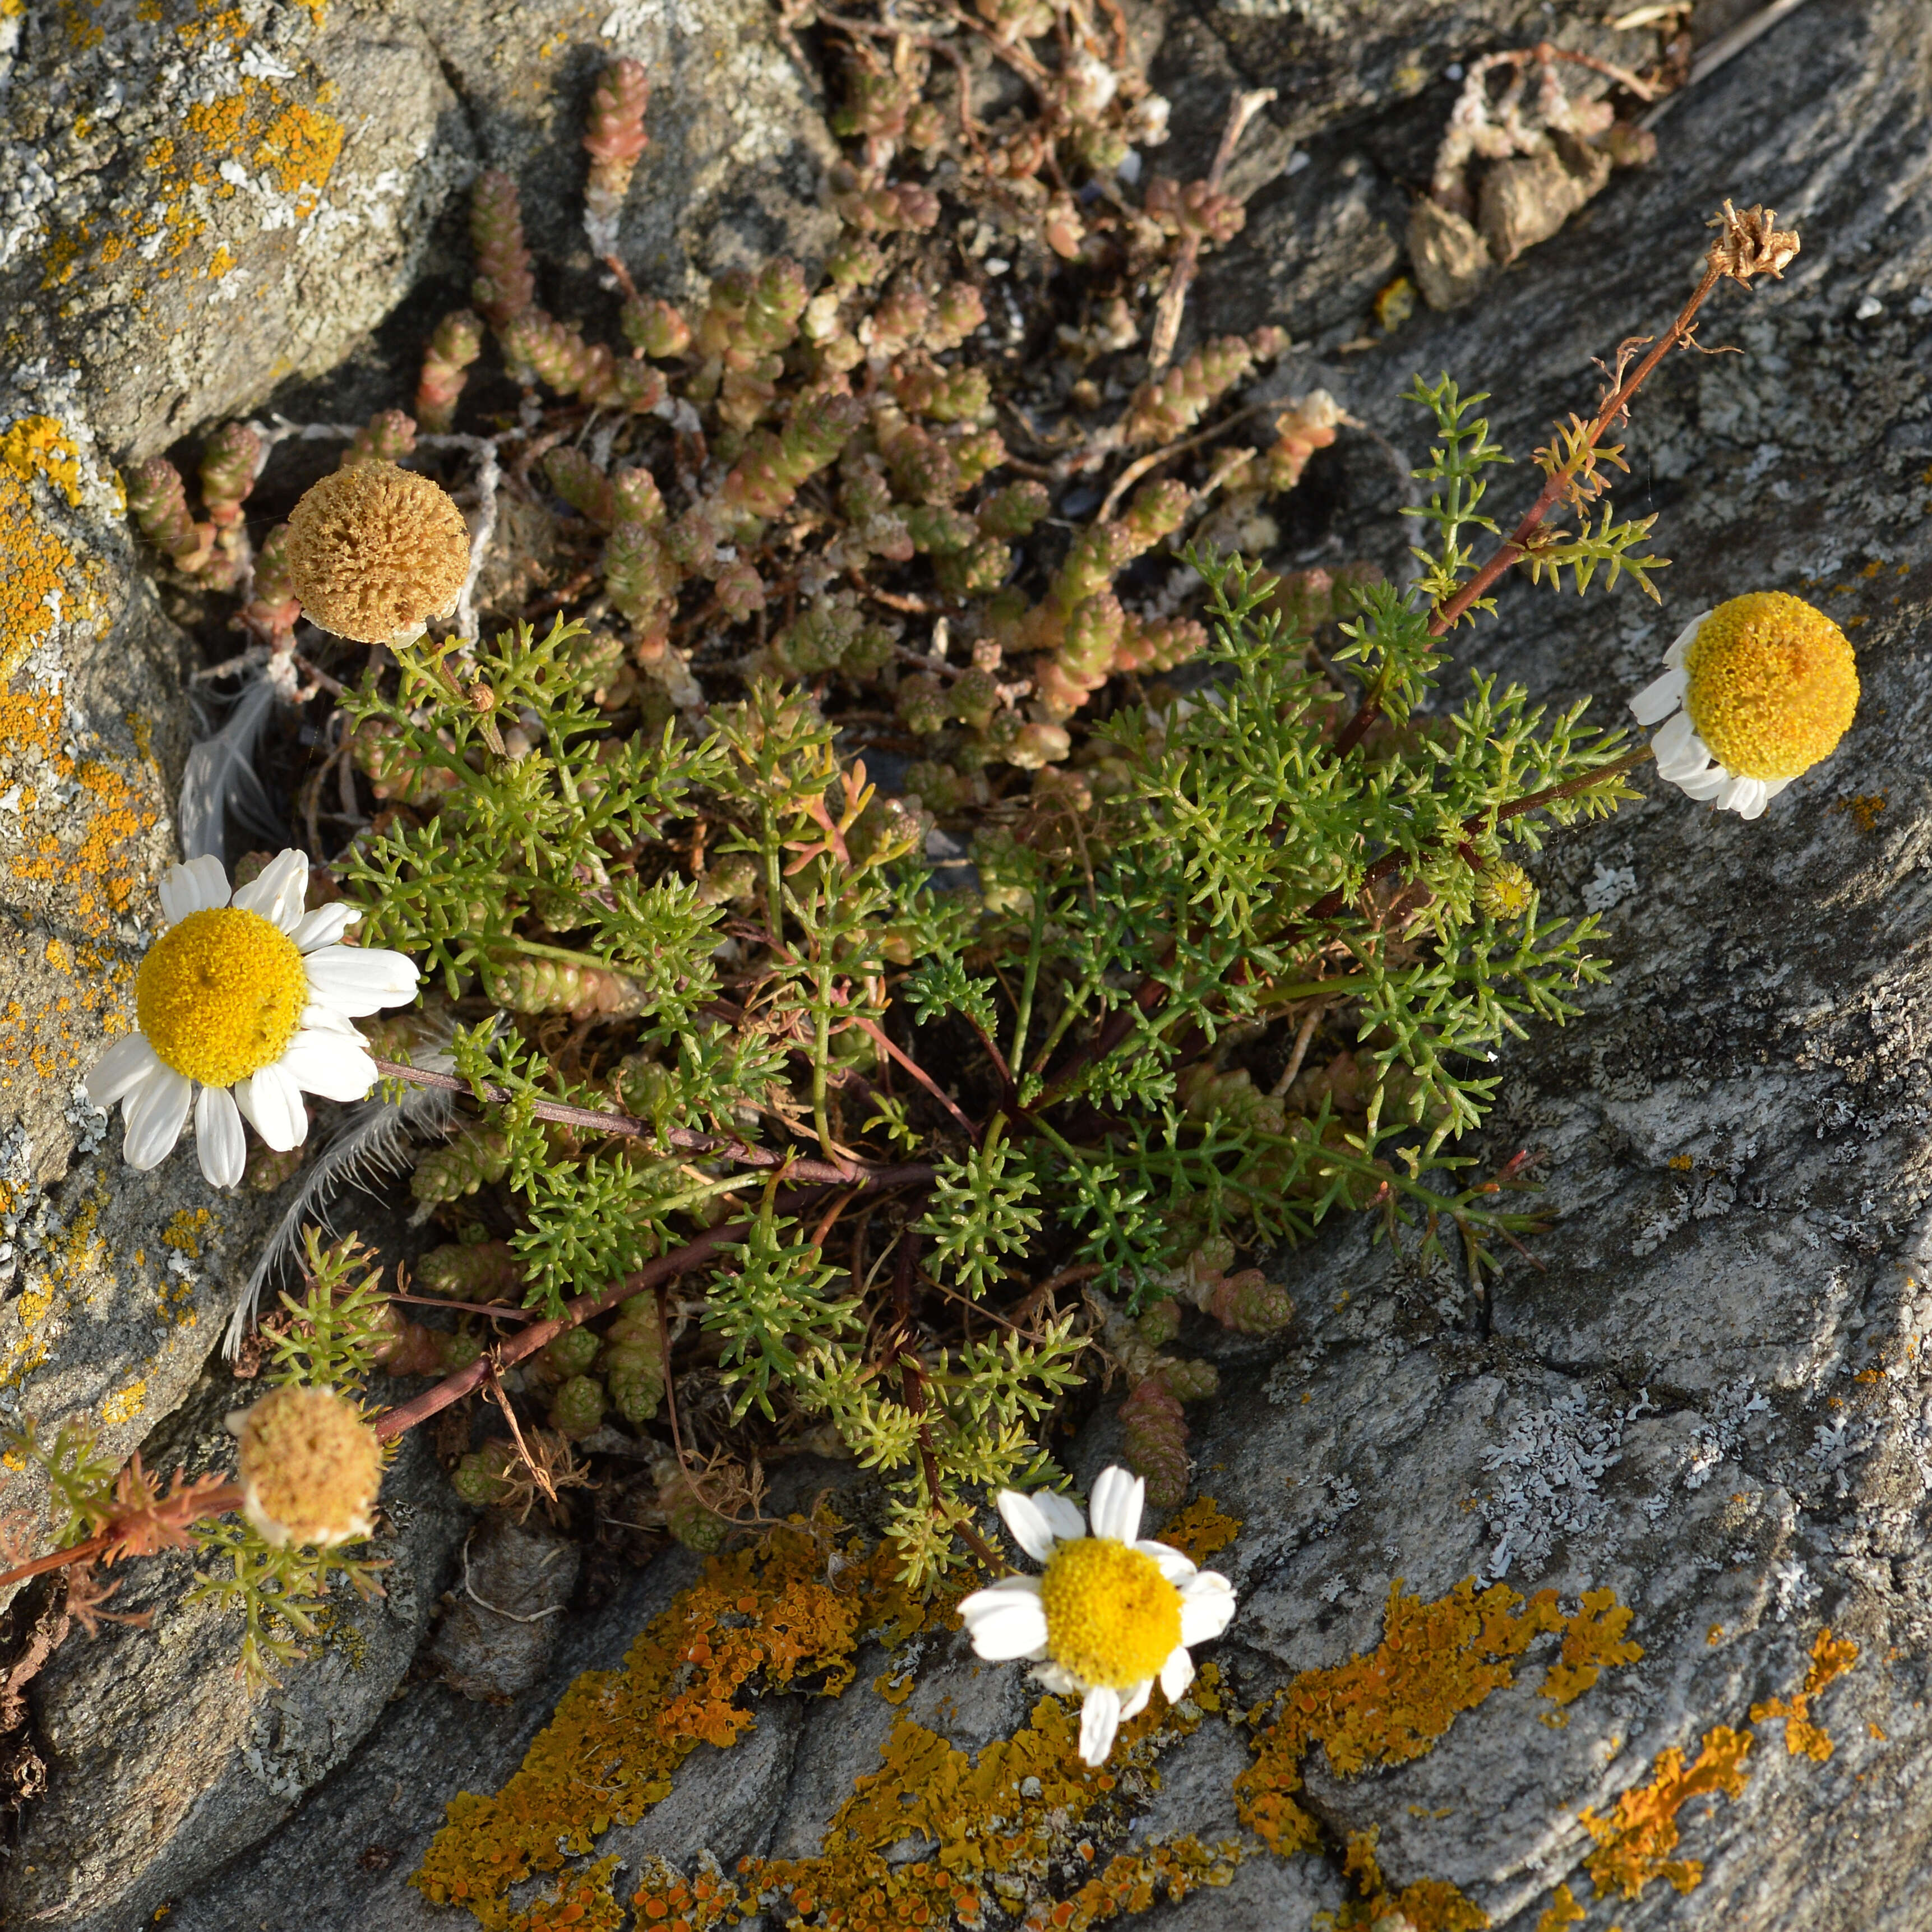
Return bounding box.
[1685,591,1859,780]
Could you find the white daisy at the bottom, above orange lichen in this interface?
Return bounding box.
[960,1468,1235,1764]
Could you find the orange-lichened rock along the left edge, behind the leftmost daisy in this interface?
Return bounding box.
[0,371,282,1607]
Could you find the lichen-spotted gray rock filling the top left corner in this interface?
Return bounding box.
[0,0,831,460]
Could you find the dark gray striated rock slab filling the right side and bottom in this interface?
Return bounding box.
[19,0,1932,1932]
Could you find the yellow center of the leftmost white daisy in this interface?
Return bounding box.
[135,906,309,1086]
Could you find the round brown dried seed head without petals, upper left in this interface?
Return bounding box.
[288,462,469,644]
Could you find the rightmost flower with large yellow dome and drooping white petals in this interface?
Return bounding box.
[1630,591,1859,819]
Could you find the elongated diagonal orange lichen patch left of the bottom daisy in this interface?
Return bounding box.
[412,1517,923,1932]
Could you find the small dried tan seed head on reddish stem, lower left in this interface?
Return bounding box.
[228,1389,382,1546]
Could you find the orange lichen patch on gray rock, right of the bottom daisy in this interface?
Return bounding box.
[1235,1577,1642,1855]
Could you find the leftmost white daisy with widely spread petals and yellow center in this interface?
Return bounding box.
[87,852,417,1188]
